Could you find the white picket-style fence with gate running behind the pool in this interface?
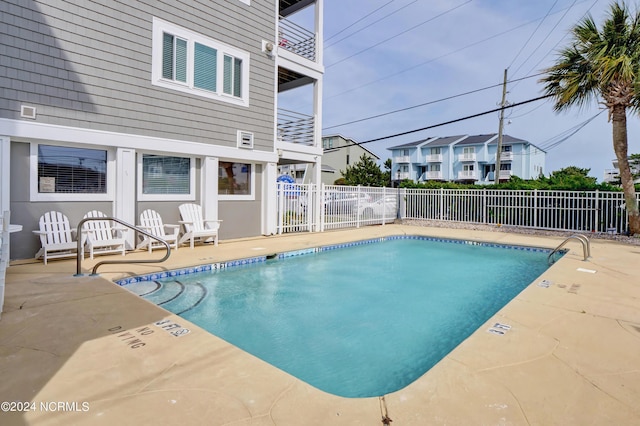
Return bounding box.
[278,183,628,233]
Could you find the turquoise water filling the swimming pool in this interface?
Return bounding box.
[127,239,548,397]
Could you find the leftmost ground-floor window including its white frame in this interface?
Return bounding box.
[30,144,115,201]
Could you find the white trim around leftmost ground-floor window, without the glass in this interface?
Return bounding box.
[29,142,116,202]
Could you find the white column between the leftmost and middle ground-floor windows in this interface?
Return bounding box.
[113,148,137,249]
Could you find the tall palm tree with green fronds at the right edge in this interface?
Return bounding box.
[540,2,640,235]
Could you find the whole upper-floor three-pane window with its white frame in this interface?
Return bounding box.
[152,18,249,106]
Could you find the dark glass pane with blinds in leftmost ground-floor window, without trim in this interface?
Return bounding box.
[38,145,107,194]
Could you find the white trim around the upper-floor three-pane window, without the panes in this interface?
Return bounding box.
[151,17,250,107]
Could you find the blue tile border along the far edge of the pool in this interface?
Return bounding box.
[114,235,556,286]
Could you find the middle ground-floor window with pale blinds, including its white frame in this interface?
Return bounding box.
[138,154,195,201]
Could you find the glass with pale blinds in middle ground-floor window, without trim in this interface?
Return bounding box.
[142,154,191,194]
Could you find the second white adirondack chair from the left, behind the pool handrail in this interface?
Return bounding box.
[82,210,128,259]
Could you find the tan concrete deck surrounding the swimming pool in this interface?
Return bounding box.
[0,225,640,426]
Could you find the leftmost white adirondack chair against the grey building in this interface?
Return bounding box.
[33,211,82,265]
